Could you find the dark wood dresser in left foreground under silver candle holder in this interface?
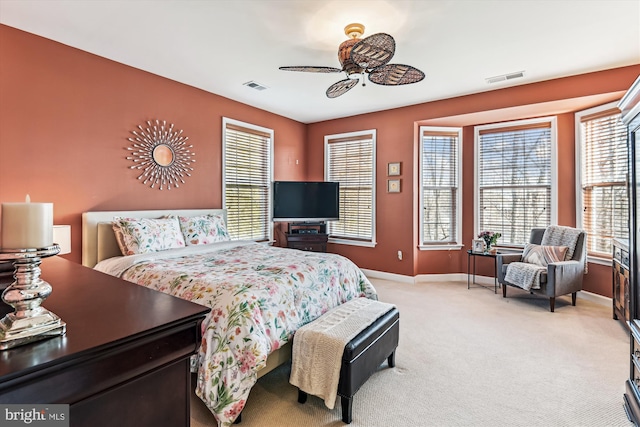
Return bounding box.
[0,257,209,427]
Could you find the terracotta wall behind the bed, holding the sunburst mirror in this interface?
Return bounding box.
[0,25,306,262]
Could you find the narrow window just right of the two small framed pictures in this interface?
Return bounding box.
[420,126,462,249]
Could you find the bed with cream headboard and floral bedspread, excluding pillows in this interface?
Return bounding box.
[82,209,377,426]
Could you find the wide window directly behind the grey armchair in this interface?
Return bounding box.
[475,118,557,246]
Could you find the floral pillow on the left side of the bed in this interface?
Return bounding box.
[113,217,185,255]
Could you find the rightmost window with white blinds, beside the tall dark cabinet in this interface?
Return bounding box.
[576,103,629,258]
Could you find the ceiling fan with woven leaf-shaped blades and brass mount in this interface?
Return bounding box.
[280,24,424,98]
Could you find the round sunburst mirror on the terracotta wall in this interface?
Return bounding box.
[127,120,195,190]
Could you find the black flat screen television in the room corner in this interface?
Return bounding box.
[273,181,340,222]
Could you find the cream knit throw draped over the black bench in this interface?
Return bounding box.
[289,298,394,409]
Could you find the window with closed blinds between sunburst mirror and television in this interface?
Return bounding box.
[222,118,273,241]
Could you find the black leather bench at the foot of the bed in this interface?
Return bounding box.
[298,307,400,424]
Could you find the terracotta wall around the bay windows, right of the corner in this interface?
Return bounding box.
[307,65,640,297]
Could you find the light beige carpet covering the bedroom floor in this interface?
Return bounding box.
[191,279,631,427]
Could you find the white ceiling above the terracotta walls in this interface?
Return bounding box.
[0,0,640,123]
